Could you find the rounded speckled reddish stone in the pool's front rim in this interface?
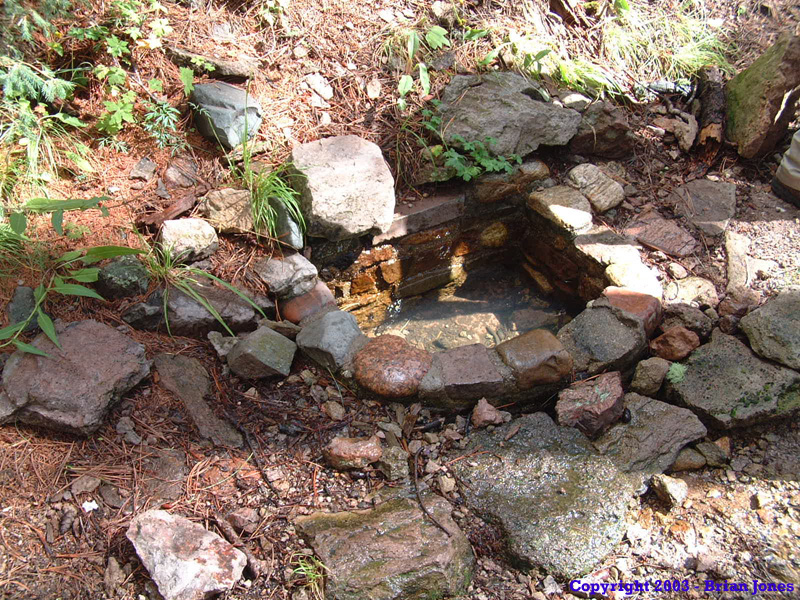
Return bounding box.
[353,335,431,398]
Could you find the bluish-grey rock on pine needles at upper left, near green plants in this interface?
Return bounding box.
[190,81,262,150]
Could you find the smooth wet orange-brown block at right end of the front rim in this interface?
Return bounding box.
[496,329,572,390]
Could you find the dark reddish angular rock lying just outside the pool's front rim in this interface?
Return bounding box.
[556,371,625,437]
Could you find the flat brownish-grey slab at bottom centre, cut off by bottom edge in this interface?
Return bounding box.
[295,494,475,600]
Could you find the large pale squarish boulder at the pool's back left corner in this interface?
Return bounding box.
[291,135,395,241]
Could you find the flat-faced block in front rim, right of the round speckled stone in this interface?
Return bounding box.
[436,344,503,400]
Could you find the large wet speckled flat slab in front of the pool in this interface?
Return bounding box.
[452,413,634,579]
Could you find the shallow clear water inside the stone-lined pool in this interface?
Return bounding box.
[367,265,570,352]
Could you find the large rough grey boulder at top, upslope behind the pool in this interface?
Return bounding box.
[439,73,581,156]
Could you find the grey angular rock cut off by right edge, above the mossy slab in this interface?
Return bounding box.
[740,290,800,370]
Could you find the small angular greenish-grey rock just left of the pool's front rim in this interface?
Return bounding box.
[228,327,297,379]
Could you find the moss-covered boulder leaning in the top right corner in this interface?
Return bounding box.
[726,32,800,158]
